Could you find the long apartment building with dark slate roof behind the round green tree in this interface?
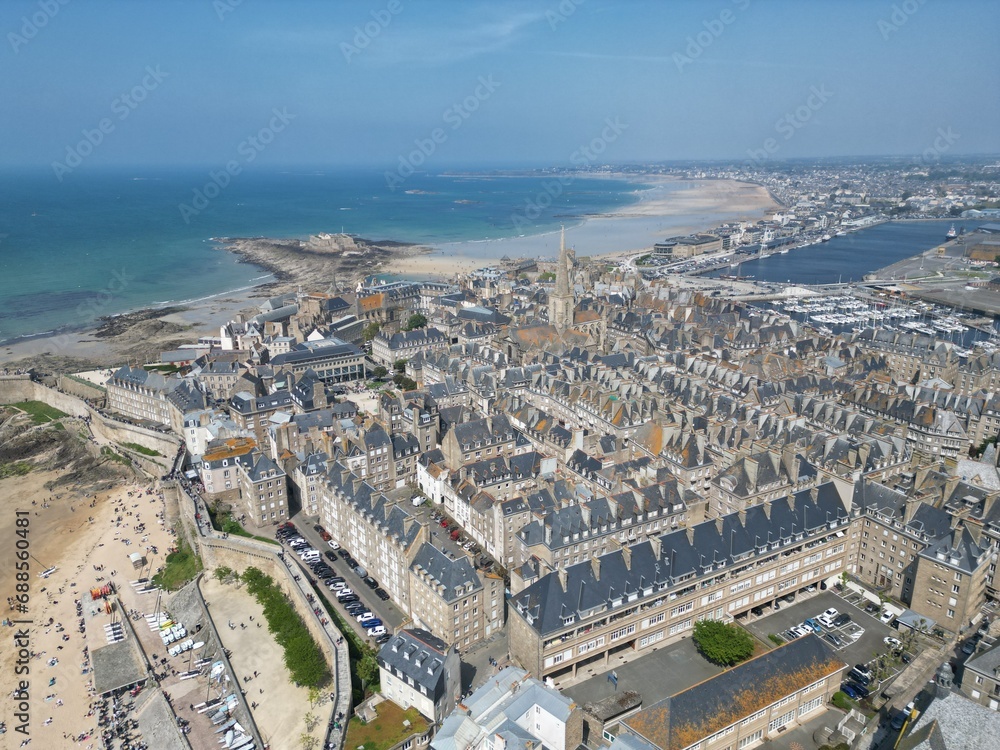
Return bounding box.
[508,482,851,682]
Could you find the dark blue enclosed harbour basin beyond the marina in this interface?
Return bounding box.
[706,219,986,284]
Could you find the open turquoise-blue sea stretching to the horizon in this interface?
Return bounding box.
[0,165,652,342]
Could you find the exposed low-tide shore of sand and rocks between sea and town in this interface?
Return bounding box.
[0,179,777,372]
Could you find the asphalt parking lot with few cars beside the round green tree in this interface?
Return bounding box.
[746,591,900,692]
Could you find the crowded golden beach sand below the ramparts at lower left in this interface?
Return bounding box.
[0,471,173,750]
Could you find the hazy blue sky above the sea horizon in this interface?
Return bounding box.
[0,0,1000,170]
